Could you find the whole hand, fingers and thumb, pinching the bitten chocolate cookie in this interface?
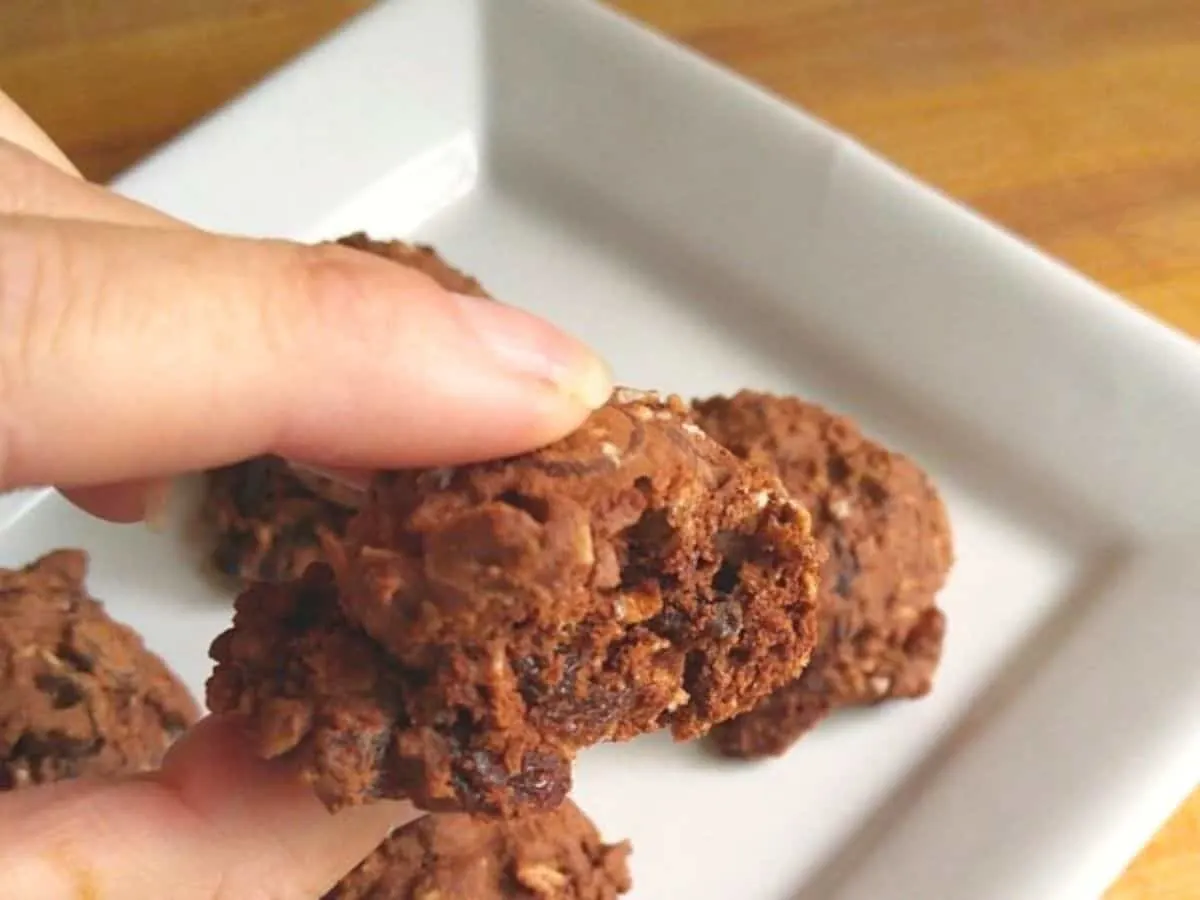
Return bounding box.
[0,94,611,900]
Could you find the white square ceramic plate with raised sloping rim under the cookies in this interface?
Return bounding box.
[9,0,1200,900]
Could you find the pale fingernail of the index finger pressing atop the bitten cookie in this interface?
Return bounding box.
[451,294,612,409]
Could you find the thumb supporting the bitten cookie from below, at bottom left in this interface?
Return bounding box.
[0,718,418,900]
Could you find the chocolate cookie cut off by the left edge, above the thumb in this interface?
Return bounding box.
[0,550,198,791]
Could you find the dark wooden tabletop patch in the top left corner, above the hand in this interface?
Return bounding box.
[0,0,371,180]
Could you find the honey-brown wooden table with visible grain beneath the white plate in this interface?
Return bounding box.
[0,0,1200,900]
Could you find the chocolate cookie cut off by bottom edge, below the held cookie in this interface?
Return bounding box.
[324,800,631,900]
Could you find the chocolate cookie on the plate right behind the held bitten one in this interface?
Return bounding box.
[694,391,953,758]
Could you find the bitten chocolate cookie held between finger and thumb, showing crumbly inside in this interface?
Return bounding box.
[209,390,818,815]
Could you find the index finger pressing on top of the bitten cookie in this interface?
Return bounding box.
[0,217,610,488]
